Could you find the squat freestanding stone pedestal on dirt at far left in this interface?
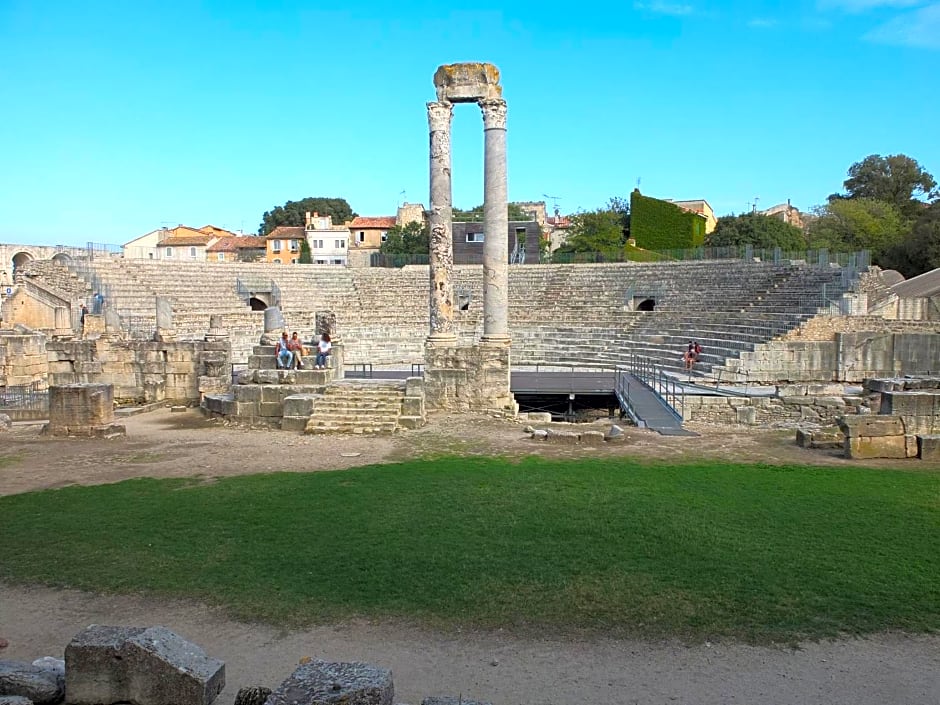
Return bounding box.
[43,384,125,438]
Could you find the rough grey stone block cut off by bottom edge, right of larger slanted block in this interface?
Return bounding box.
[265,659,395,705]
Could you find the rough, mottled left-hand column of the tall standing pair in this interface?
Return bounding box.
[428,102,457,344]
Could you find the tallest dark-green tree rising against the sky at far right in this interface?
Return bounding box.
[831,154,940,217]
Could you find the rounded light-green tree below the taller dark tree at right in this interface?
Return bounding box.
[809,198,911,264]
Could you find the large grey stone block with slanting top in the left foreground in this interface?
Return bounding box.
[65,625,225,705]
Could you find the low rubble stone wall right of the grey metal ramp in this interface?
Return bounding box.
[683,384,871,427]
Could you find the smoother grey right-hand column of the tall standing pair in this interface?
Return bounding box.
[480,98,509,343]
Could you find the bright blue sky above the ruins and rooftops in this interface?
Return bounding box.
[0,0,940,244]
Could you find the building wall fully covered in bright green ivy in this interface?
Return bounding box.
[630,189,706,250]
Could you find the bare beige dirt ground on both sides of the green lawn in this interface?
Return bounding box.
[0,410,940,705]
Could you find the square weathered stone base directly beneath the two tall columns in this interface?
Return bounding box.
[424,343,518,416]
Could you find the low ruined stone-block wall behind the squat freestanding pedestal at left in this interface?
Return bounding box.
[46,336,231,404]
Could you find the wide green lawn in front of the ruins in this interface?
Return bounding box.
[0,458,940,641]
